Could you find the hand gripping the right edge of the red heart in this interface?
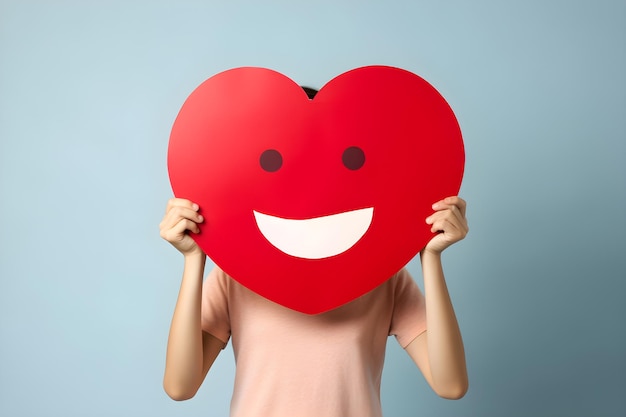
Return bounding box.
[422,196,469,254]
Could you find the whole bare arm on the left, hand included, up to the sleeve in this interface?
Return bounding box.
[160,199,224,400]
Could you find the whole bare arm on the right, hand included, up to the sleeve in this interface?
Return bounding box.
[406,197,468,399]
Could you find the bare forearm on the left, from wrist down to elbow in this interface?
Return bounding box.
[163,254,206,400]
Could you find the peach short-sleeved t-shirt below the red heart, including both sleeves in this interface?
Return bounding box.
[202,267,426,417]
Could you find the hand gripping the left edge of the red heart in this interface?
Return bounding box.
[159,198,204,256]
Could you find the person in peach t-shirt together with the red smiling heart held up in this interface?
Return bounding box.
[160,67,468,417]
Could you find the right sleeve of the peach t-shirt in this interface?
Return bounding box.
[389,268,426,348]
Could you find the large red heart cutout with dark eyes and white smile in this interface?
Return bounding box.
[168,66,464,314]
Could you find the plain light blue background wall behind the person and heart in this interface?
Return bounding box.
[0,0,626,417]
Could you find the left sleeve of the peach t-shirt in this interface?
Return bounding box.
[200,267,230,345]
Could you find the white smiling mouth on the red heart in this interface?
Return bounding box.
[253,207,374,259]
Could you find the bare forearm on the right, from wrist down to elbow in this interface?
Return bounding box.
[421,251,468,398]
